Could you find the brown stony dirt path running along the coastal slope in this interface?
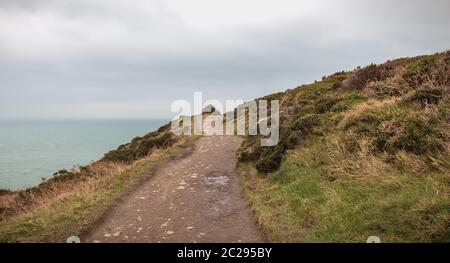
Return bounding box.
[82,136,264,242]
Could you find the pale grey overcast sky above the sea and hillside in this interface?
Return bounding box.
[0,0,450,119]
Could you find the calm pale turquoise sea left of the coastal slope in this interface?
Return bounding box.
[0,119,168,190]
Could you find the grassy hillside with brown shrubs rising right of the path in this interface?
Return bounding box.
[239,52,450,242]
